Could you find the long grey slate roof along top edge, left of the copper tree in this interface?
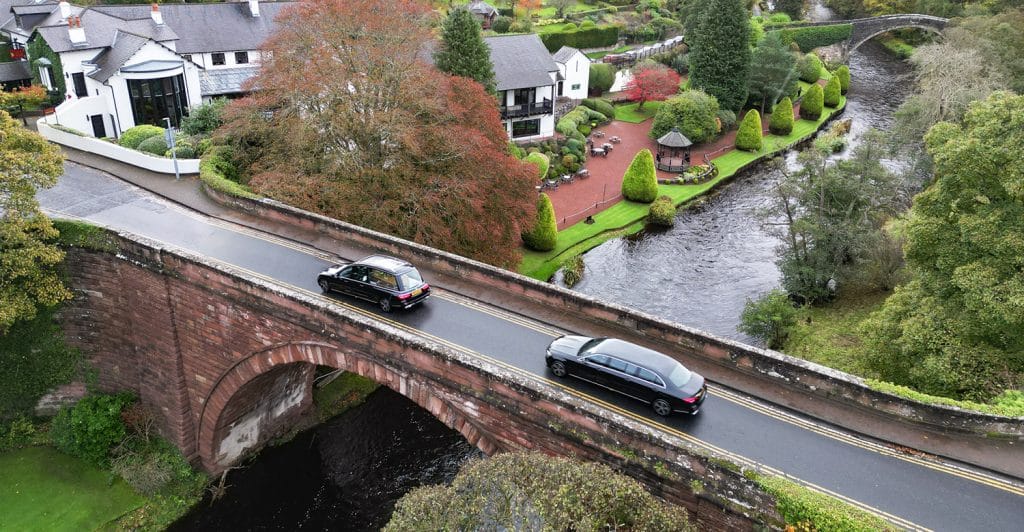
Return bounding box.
[93,2,293,53]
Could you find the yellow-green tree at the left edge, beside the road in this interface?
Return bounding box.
[0,110,71,335]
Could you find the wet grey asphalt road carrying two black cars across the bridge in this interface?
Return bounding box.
[38,163,1024,531]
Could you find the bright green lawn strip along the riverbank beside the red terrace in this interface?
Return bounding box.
[517,95,846,281]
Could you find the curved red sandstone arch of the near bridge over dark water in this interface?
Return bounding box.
[198,342,501,472]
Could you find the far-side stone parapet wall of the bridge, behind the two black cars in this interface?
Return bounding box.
[207,188,1024,466]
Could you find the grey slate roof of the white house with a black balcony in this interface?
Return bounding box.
[483,34,558,90]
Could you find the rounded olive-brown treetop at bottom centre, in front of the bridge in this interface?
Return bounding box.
[384,453,693,532]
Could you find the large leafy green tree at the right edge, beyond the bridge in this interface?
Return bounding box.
[864,92,1024,400]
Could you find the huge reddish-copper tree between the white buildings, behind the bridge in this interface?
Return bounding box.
[218,0,537,267]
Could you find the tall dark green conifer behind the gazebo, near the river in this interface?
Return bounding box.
[689,0,751,112]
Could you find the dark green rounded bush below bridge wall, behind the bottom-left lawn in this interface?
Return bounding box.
[51,394,133,466]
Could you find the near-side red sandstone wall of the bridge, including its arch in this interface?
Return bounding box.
[62,229,781,530]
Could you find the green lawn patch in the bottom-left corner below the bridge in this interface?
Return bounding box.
[0,447,144,531]
